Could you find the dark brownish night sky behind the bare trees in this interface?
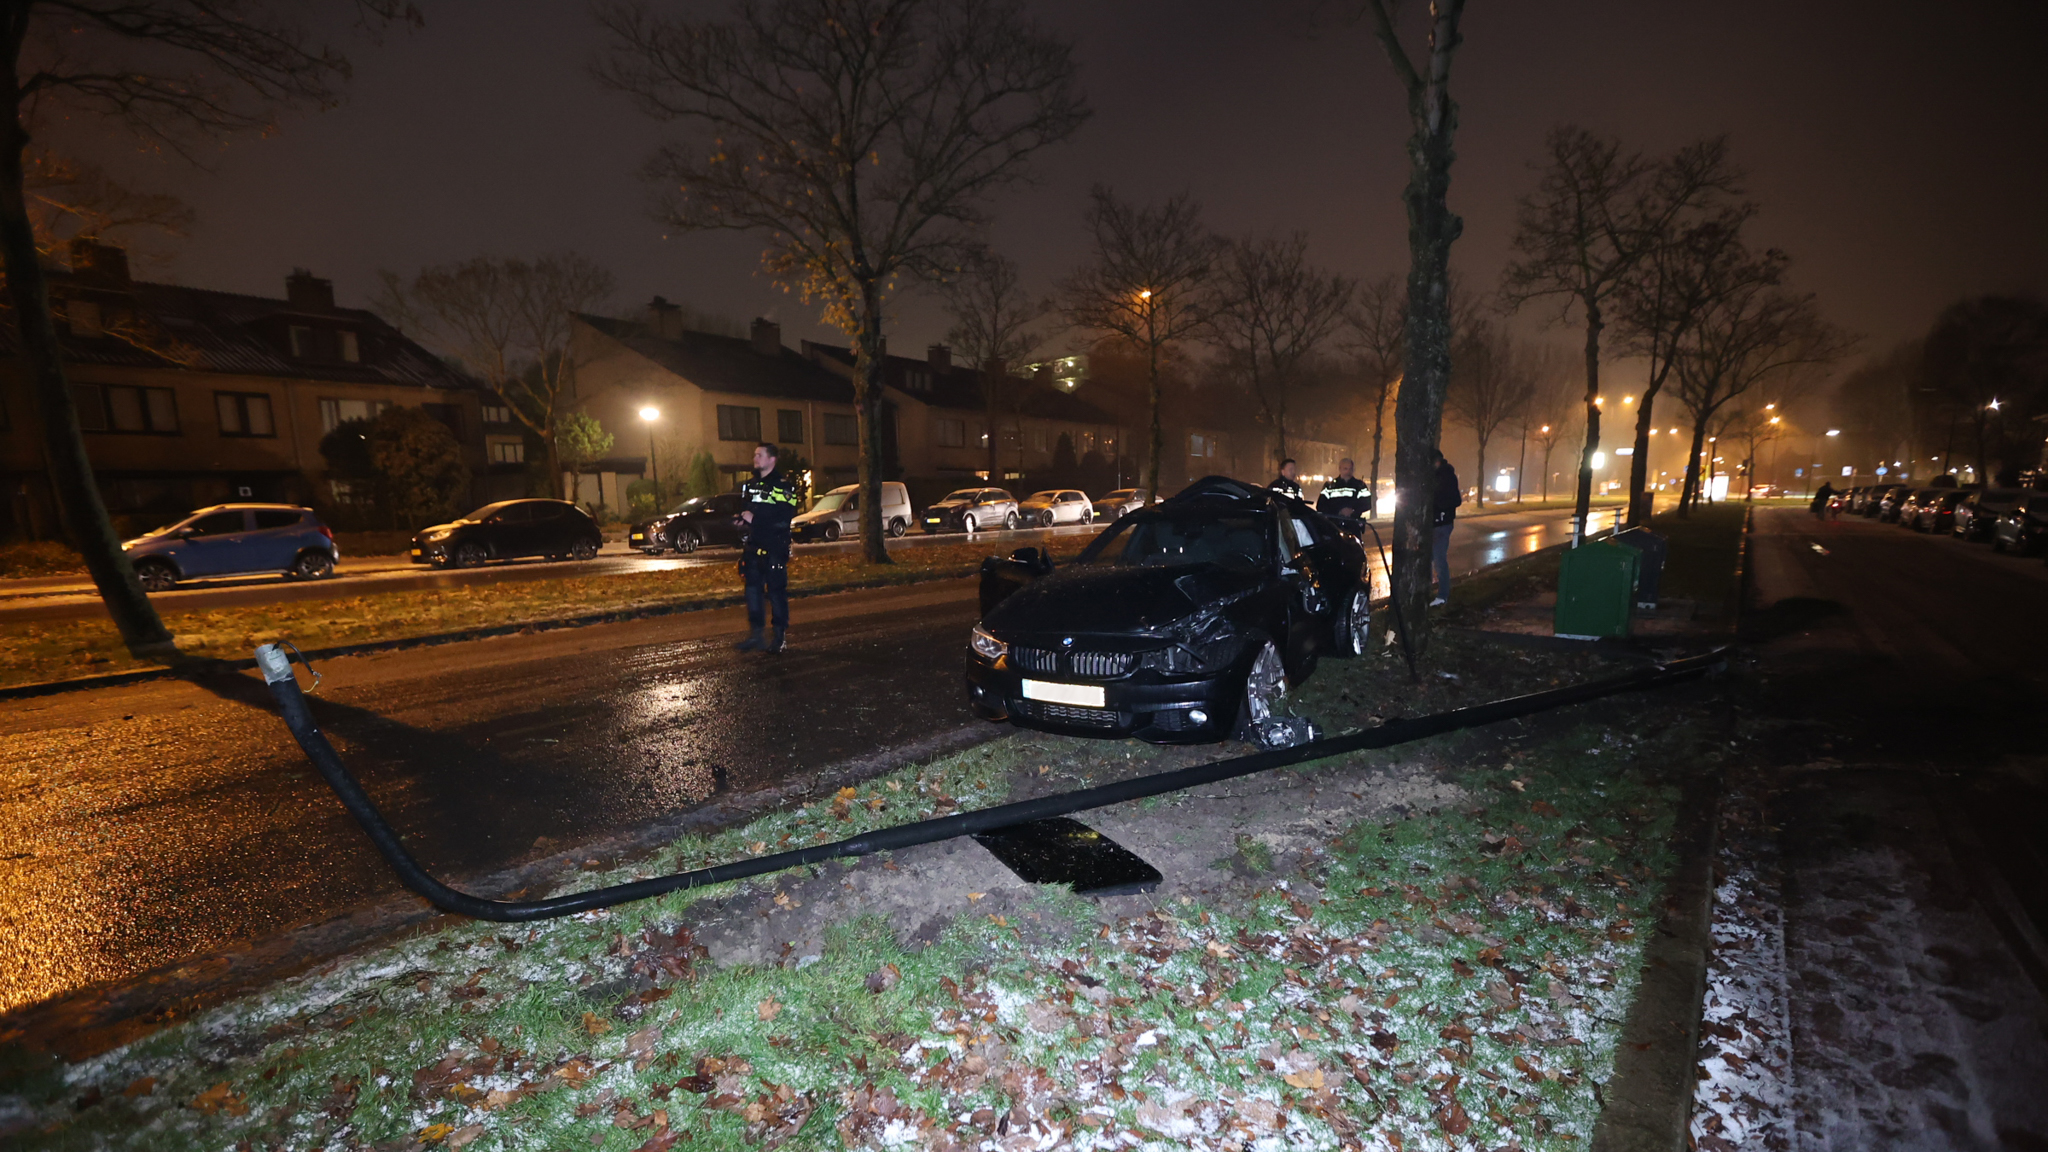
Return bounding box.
[56,0,2048,385]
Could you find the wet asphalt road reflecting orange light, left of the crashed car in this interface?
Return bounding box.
[0,502,1597,1013]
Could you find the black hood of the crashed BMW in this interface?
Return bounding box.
[985,564,1260,635]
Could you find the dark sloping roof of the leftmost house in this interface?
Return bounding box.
[0,271,479,387]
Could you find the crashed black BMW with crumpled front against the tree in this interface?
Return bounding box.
[967,478,1370,746]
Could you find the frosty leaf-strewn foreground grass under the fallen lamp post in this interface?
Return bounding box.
[0,637,1712,1152]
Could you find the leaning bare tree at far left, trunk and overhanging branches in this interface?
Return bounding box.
[0,0,418,658]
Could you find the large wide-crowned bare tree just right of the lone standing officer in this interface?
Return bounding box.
[594,0,1090,564]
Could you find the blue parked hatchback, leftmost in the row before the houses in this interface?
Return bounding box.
[121,504,342,592]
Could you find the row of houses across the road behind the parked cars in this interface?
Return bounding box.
[0,242,1341,537]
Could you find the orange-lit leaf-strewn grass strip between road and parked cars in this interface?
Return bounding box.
[0,537,1087,687]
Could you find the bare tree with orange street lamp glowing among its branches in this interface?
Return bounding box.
[1059,184,1219,502]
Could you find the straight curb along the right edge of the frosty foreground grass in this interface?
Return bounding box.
[1591,773,1720,1152]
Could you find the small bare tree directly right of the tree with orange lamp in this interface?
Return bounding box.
[1210,232,1358,459]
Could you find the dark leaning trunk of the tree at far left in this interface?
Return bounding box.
[0,49,178,660]
